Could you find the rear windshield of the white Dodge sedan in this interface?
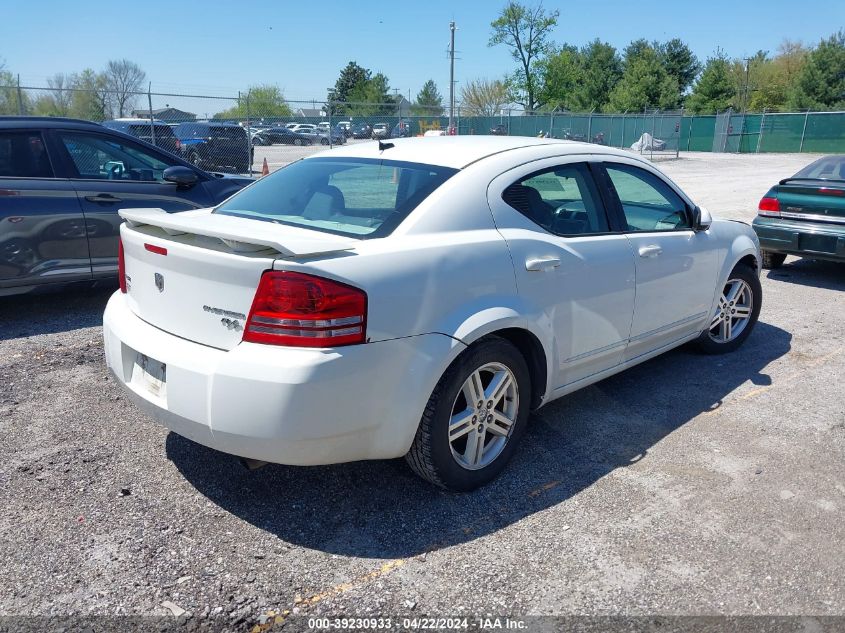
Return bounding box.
[214,158,457,238]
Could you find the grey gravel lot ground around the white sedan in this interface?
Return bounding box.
[0,148,845,628]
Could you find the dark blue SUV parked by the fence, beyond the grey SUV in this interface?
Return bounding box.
[173,121,252,174]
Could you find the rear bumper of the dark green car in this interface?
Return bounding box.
[752,216,845,261]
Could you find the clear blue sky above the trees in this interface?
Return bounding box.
[0,0,845,111]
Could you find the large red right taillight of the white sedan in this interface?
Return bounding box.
[243,271,367,347]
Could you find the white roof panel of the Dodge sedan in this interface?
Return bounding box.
[315,136,632,169]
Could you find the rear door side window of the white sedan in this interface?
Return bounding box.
[502,163,610,236]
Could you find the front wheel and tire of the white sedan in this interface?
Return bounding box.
[696,264,763,354]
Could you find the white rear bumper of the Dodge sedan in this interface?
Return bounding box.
[103,292,462,465]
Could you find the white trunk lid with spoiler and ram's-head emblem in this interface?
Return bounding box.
[120,209,357,350]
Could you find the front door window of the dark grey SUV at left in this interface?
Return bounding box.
[60,132,175,182]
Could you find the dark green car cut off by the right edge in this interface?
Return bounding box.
[753,155,845,268]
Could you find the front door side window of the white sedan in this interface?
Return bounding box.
[605,163,691,232]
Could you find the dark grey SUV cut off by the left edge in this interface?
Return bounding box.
[0,117,252,297]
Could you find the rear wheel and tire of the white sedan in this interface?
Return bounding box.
[405,337,531,491]
